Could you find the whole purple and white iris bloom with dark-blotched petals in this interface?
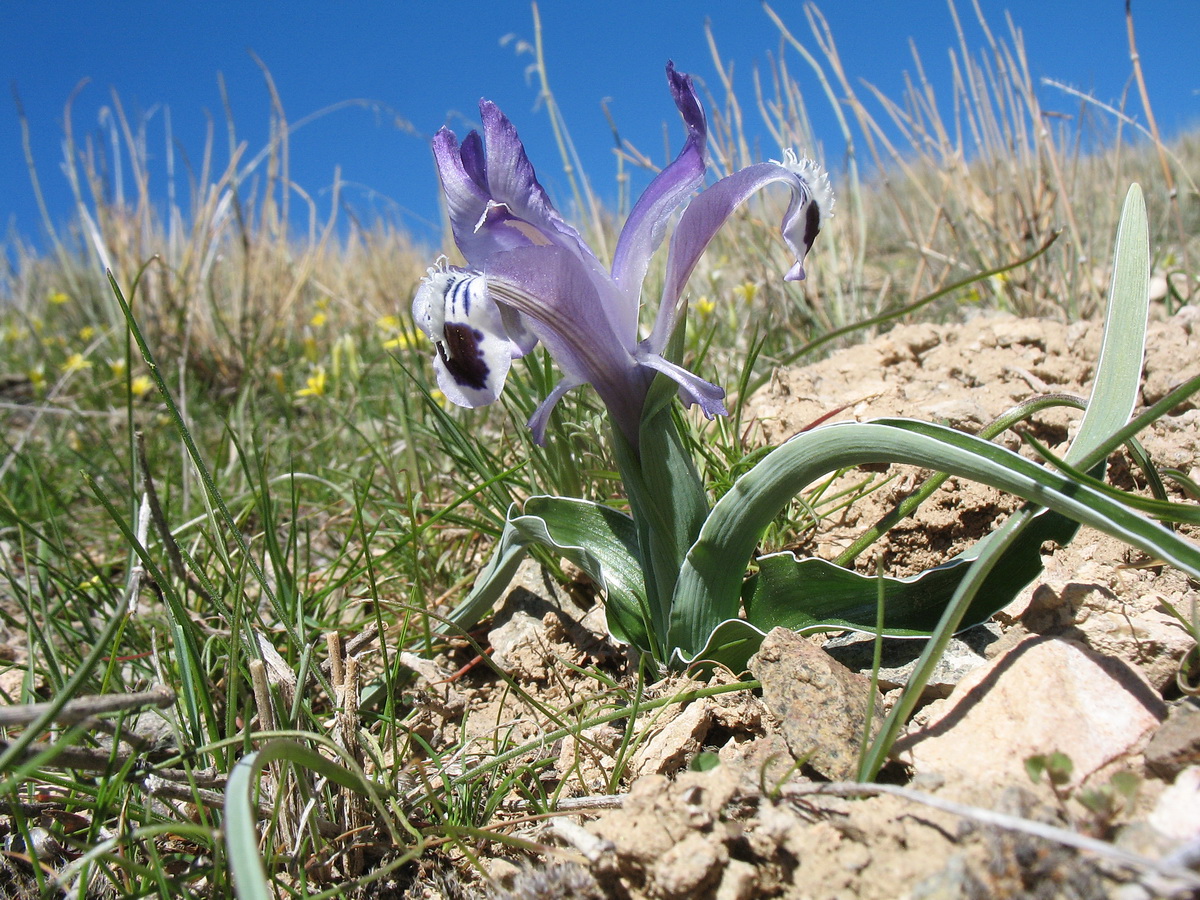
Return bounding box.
[413,62,833,448]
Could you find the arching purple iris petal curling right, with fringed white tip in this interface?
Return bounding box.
[646,150,834,353]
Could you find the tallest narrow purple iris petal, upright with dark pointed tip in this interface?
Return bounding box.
[612,62,708,331]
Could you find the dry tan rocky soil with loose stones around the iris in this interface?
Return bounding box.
[410,316,1200,900]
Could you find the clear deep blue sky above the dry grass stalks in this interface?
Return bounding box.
[0,0,1200,252]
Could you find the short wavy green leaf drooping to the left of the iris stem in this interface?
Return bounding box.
[439,497,652,650]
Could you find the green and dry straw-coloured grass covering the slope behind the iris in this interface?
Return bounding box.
[0,7,1198,896]
